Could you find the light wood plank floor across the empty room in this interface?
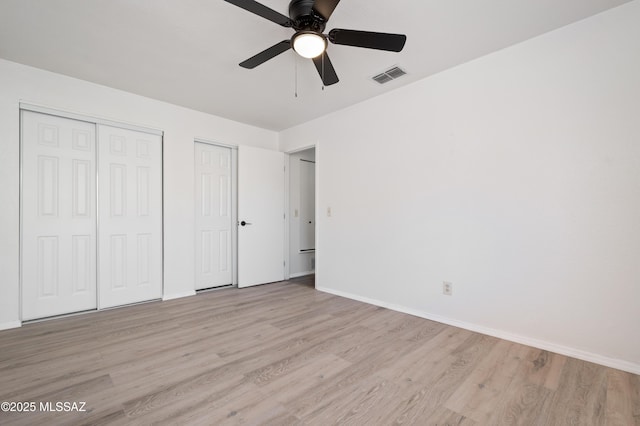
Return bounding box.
[0,278,640,426]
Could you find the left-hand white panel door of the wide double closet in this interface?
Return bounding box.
[21,111,96,320]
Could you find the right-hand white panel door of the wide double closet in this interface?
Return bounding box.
[98,124,162,308]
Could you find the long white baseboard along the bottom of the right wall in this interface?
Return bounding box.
[316,287,640,375]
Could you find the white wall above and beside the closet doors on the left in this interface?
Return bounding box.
[0,60,278,329]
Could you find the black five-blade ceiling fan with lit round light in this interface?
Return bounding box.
[225,0,407,86]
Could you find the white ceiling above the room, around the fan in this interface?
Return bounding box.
[0,0,629,130]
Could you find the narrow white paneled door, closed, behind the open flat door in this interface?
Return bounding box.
[195,142,233,290]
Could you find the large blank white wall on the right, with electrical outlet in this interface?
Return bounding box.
[280,1,640,373]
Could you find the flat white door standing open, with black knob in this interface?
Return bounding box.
[238,146,285,287]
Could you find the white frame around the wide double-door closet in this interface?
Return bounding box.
[18,102,165,323]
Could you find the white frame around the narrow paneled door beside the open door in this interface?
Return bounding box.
[193,138,238,292]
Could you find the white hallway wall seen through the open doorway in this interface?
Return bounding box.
[288,148,316,277]
